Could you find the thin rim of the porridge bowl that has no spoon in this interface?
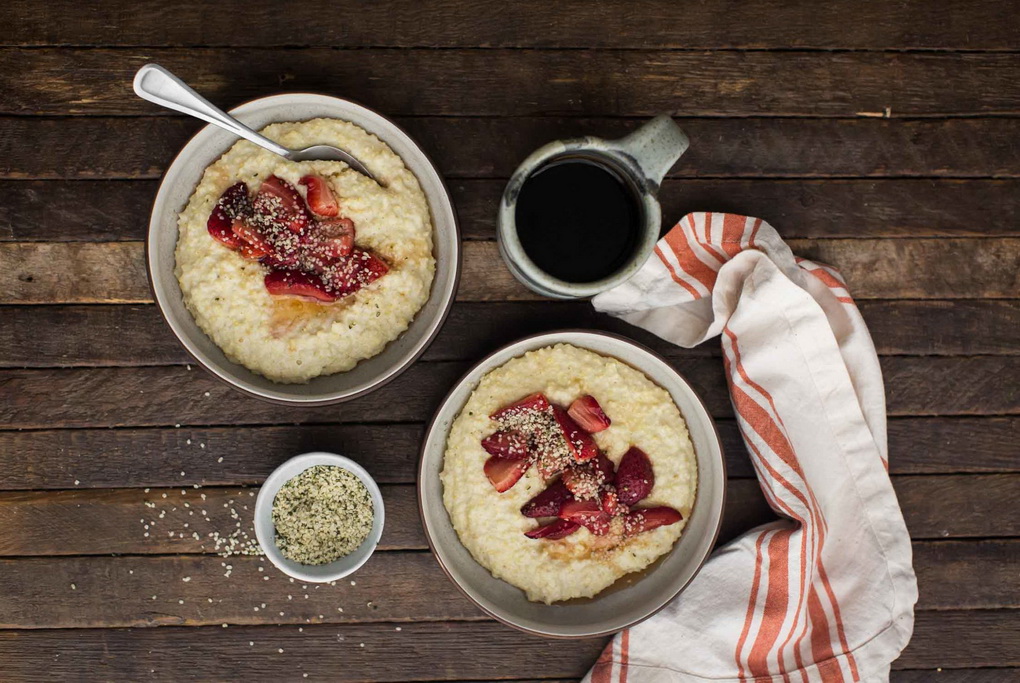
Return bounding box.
[416,328,726,640]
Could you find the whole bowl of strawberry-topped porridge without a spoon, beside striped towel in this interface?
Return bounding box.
[418,330,725,637]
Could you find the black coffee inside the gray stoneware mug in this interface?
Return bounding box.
[514,158,643,282]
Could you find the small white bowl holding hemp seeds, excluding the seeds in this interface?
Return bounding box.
[255,453,386,583]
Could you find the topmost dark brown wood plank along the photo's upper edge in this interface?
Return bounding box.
[3,0,1020,50]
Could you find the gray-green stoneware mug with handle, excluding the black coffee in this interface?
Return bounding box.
[498,115,690,299]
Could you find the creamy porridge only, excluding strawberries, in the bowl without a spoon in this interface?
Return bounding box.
[442,345,698,603]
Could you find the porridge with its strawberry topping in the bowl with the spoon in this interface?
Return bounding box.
[175,118,436,382]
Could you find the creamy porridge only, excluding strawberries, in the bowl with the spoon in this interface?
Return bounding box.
[175,118,436,382]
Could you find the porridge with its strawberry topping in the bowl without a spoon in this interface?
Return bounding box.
[442,344,698,603]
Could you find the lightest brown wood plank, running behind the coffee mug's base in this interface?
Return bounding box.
[0,238,1020,304]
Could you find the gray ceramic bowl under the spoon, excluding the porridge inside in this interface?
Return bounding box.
[146,93,460,406]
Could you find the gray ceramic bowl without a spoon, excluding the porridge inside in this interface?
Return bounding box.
[418,330,726,638]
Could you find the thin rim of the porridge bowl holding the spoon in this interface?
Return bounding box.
[144,91,463,407]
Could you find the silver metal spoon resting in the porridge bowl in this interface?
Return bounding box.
[135,64,375,180]
